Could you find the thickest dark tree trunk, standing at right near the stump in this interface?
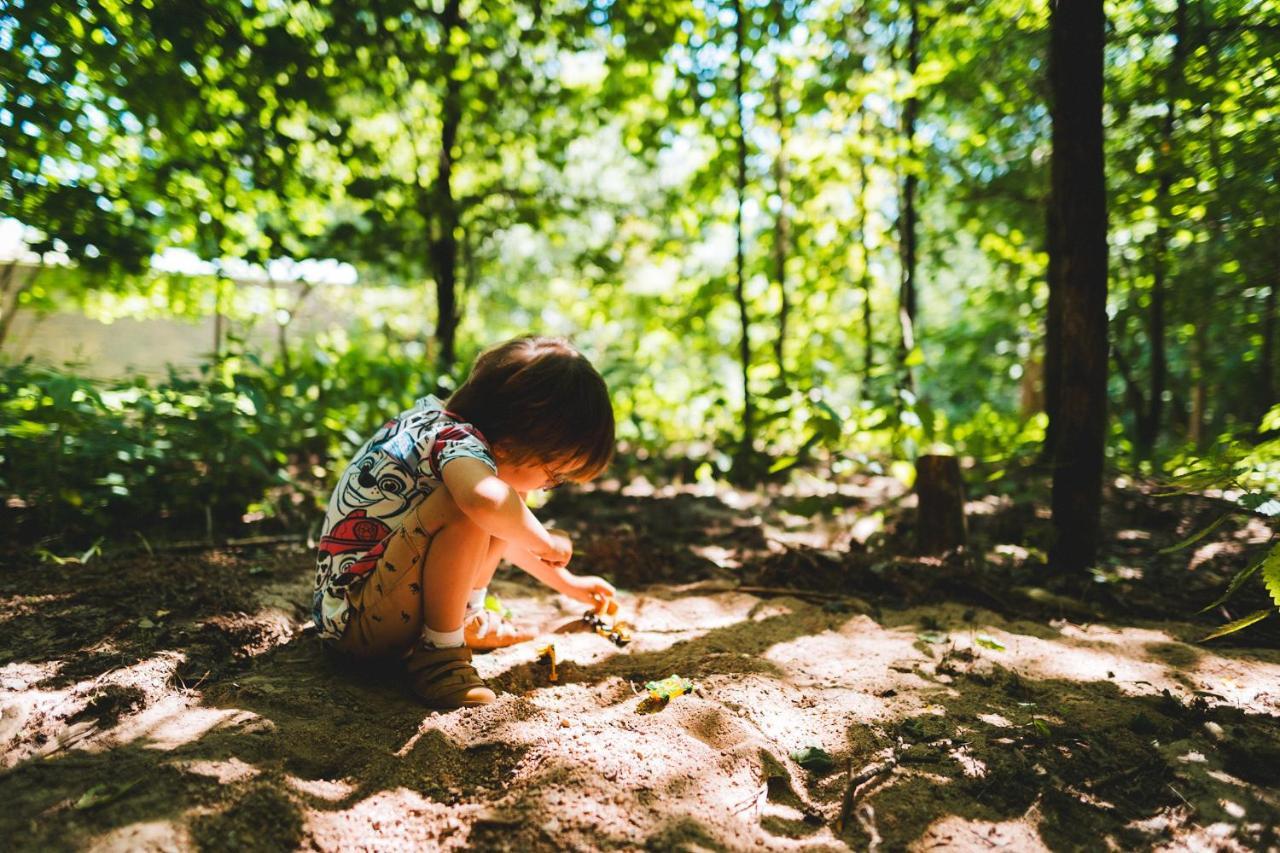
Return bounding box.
[1048,0,1108,571]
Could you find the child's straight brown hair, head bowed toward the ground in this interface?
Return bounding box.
[447,336,614,483]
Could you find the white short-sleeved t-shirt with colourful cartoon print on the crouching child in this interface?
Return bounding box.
[312,396,498,639]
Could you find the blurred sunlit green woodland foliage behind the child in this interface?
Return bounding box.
[0,0,1280,533]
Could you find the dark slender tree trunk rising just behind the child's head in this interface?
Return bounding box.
[424,0,463,375]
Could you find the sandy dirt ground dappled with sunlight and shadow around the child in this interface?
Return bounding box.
[0,473,1280,850]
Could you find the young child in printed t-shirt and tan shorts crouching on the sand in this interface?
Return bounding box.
[314,337,614,708]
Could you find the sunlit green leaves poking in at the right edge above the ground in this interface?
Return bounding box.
[1161,406,1280,642]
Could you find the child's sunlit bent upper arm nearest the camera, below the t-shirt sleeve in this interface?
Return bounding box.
[440,457,573,568]
